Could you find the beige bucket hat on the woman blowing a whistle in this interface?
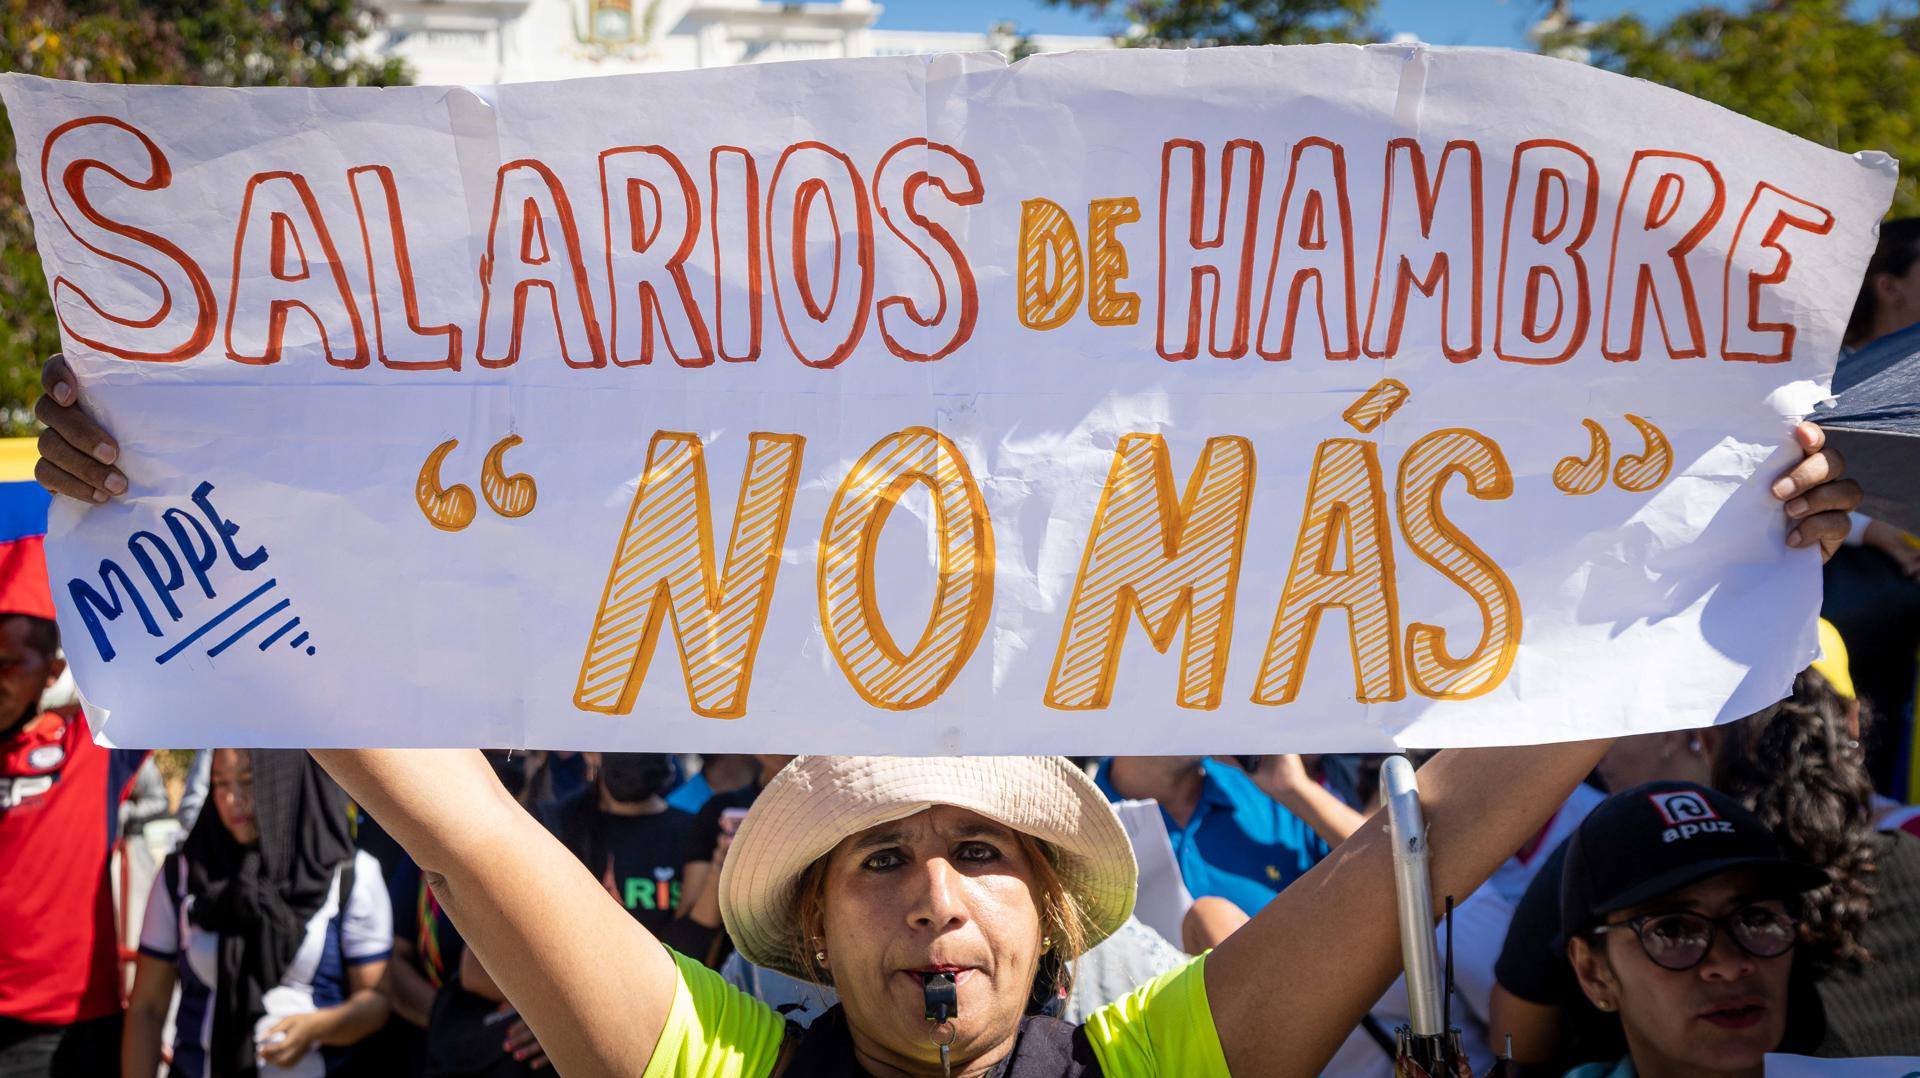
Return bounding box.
[720,755,1139,978]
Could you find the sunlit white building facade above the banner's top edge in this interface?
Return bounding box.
[369,0,1114,85]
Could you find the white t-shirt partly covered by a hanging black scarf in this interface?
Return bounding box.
[140,851,394,1078]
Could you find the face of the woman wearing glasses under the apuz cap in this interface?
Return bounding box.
[1571,872,1793,1074]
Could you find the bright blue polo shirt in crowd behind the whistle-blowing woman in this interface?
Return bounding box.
[1094,759,1327,915]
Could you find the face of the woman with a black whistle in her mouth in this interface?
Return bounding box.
[820,807,1043,1072]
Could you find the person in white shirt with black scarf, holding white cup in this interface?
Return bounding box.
[121,749,394,1078]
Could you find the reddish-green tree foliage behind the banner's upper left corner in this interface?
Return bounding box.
[0,0,407,434]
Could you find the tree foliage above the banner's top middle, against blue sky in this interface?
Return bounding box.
[1048,0,1375,46]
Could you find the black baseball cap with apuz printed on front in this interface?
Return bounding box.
[1561,782,1828,943]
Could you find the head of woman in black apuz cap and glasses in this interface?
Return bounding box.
[1561,782,1826,1078]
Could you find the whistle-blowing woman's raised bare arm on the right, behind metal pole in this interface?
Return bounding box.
[1206,742,1609,1078]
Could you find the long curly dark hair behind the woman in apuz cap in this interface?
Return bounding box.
[1713,671,1880,968]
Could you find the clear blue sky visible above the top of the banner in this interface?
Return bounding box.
[877,0,1692,48]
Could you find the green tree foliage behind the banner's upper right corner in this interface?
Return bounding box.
[1542,0,1920,215]
